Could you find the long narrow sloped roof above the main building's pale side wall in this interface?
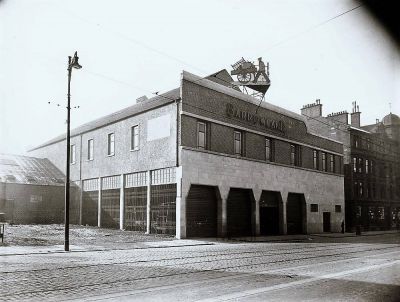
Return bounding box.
[29,88,180,151]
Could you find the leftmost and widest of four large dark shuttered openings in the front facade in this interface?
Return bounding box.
[186,185,217,237]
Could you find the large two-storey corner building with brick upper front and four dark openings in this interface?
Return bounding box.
[31,70,344,238]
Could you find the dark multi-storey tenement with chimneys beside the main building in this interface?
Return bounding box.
[301,100,400,231]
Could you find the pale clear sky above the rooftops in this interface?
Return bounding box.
[0,0,400,155]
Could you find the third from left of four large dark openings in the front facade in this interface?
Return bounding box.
[260,191,280,236]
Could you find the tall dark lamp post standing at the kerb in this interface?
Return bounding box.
[64,51,82,251]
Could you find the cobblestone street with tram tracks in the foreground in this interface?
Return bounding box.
[0,233,400,301]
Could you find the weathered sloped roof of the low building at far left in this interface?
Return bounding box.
[0,153,65,186]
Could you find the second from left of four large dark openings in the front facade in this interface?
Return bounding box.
[227,188,253,237]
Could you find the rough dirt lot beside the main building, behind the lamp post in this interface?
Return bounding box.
[0,224,174,246]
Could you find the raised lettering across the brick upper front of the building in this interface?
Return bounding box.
[226,104,285,133]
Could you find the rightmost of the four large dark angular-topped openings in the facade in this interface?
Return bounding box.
[286,193,305,235]
